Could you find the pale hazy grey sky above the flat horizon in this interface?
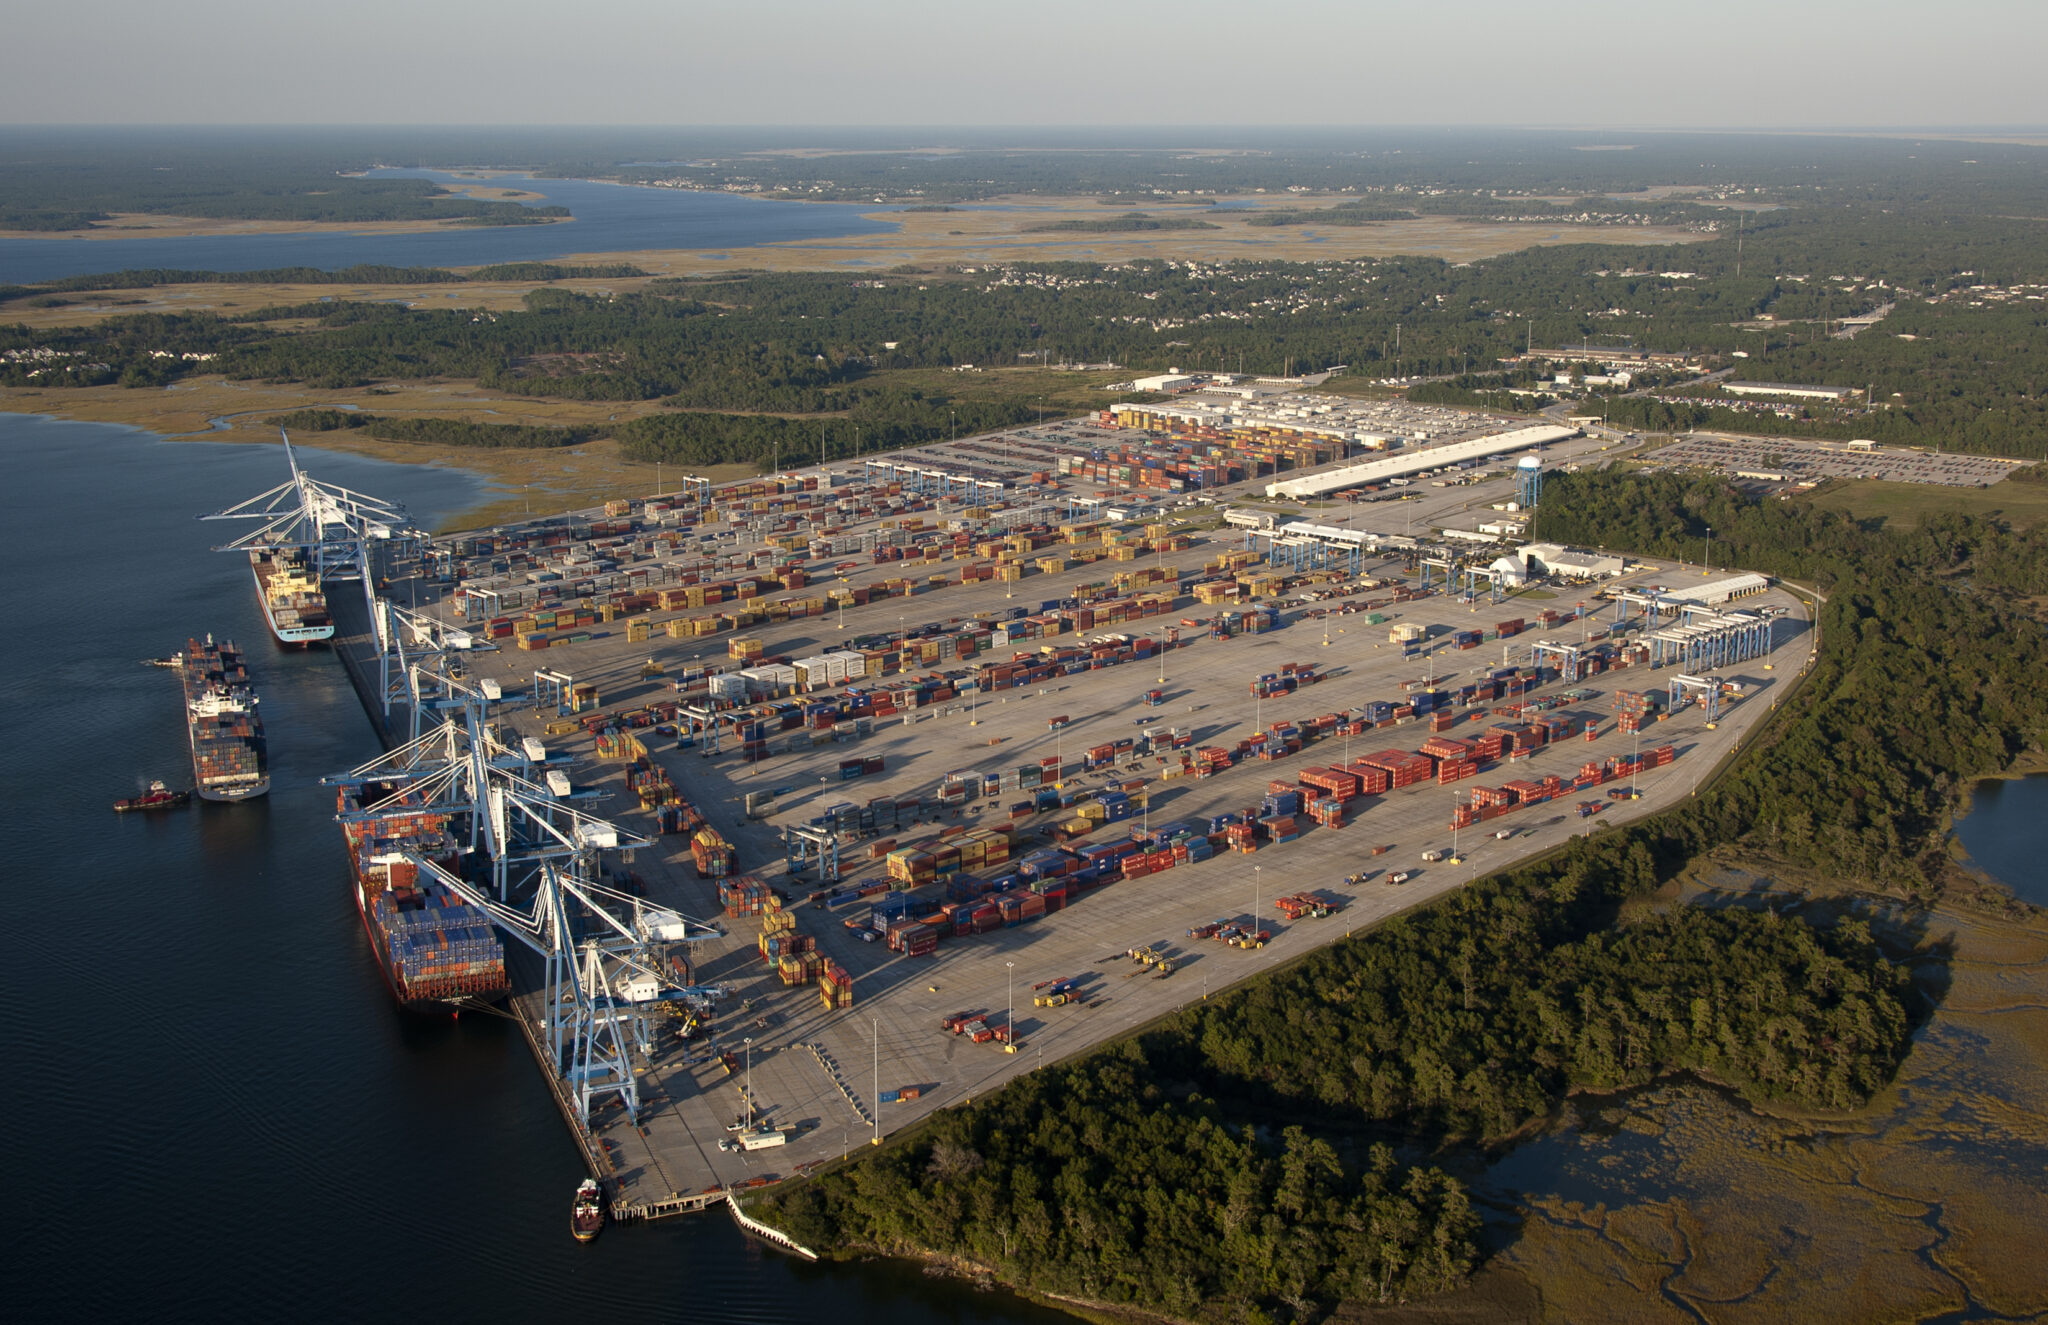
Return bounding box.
[0,0,2048,127]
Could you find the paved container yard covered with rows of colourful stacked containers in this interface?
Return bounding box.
[311,409,1812,1219]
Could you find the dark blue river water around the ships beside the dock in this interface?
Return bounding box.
[0,414,1063,1325]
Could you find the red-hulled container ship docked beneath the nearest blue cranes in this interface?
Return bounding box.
[336,782,512,1016]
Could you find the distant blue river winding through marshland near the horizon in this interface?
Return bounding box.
[0,170,895,285]
